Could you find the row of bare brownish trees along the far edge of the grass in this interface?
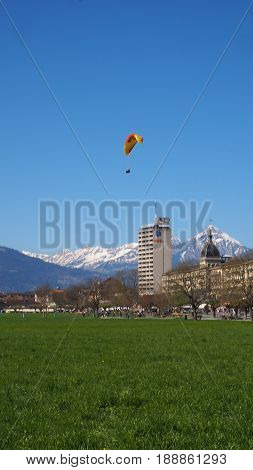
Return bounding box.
[6,258,253,320]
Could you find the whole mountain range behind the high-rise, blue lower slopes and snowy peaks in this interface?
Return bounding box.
[0,226,249,292]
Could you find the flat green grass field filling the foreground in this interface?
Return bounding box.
[0,314,253,449]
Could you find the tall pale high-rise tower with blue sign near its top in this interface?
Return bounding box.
[138,217,172,295]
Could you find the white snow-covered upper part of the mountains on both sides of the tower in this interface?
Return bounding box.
[24,225,247,274]
